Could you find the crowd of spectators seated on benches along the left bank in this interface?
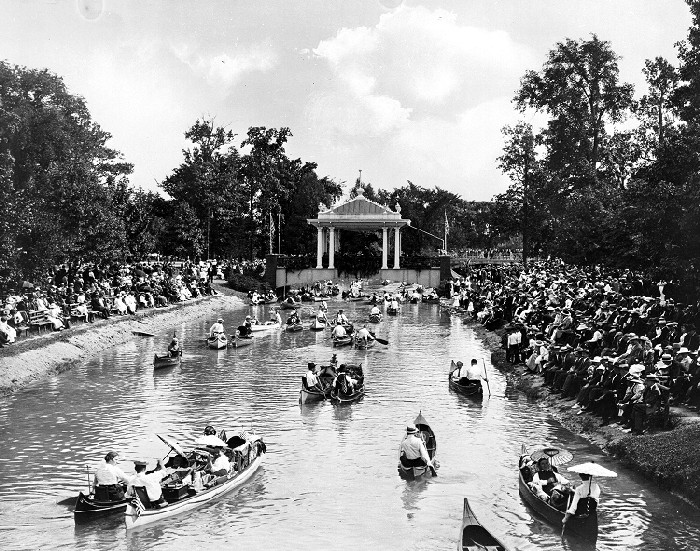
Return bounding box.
[0,261,223,347]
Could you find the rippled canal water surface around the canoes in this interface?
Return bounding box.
[0,302,700,550]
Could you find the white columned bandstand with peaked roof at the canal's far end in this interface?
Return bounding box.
[307,195,411,270]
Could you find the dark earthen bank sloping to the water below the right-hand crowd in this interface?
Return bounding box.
[462,312,700,507]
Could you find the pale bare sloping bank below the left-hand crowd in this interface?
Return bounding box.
[0,295,243,395]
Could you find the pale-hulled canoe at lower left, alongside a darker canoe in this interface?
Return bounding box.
[124,436,266,530]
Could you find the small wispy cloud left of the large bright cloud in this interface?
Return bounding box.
[170,44,278,90]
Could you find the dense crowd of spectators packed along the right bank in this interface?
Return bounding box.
[448,261,700,433]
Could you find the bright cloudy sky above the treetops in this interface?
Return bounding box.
[0,0,691,201]
